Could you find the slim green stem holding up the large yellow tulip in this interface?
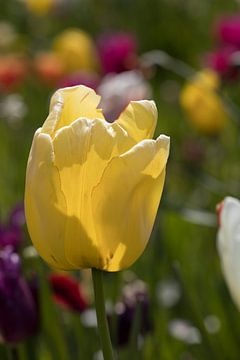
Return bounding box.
[92,269,114,360]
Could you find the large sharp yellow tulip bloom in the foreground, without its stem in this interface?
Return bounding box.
[25,86,169,271]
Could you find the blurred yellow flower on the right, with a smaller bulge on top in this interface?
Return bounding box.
[180,69,227,135]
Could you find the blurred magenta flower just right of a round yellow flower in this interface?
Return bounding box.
[97,33,138,74]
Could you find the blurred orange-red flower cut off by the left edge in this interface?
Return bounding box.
[0,55,27,91]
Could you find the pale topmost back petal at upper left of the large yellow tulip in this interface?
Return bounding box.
[42,85,104,136]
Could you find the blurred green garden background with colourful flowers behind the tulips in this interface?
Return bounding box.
[0,0,240,360]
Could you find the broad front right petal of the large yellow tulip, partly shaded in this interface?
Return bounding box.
[92,135,169,271]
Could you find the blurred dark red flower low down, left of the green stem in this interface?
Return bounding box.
[49,273,88,313]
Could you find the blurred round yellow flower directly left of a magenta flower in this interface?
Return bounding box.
[53,28,98,73]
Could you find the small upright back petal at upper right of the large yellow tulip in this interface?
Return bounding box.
[117,100,158,143]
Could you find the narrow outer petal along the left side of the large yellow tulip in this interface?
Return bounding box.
[25,129,72,270]
